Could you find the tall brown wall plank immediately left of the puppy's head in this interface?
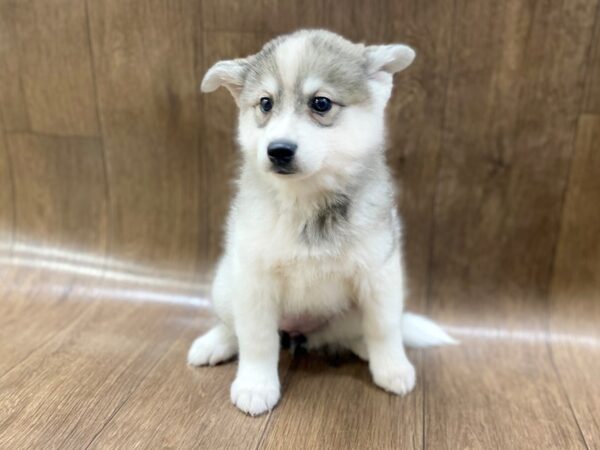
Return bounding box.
[88,0,208,276]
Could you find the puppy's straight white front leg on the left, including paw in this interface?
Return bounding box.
[231,277,280,416]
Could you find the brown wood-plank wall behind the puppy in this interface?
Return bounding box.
[0,0,600,321]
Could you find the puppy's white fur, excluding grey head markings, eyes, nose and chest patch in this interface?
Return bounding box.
[188,30,453,415]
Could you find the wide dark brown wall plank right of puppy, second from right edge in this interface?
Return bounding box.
[432,0,596,320]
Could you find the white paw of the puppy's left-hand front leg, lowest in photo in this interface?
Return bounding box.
[231,376,280,416]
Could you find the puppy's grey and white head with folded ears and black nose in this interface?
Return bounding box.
[201,30,415,180]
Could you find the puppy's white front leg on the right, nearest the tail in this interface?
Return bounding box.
[359,254,415,395]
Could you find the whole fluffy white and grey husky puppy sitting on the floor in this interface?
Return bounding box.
[188,30,453,415]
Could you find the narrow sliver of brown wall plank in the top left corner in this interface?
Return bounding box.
[0,0,30,130]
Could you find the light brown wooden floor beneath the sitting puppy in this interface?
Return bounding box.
[0,262,600,449]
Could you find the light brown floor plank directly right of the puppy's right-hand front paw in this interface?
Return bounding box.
[424,336,585,449]
